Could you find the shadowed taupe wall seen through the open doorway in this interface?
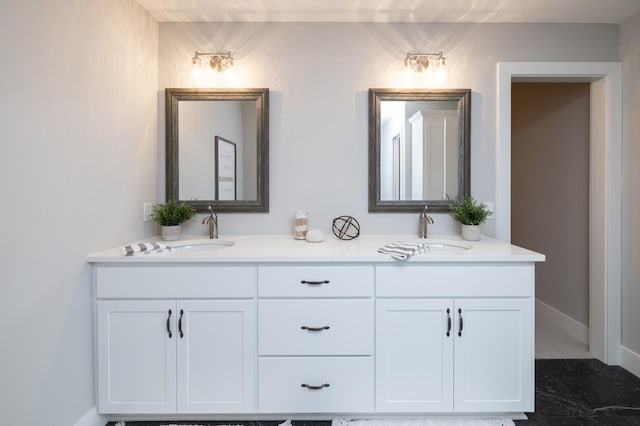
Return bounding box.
[511,83,590,327]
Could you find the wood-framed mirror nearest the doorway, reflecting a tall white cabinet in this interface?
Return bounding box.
[369,89,471,212]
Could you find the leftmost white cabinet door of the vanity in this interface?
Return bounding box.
[97,301,177,413]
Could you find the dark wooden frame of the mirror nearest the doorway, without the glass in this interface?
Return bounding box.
[369,89,471,213]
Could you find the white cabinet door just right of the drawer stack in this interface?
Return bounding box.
[376,299,453,412]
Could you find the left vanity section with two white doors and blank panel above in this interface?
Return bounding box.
[96,266,256,414]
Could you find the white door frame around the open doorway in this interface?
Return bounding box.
[495,62,622,365]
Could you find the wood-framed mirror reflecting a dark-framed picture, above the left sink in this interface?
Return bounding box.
[166,89,269,211]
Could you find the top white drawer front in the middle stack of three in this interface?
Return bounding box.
[258,265,373,297]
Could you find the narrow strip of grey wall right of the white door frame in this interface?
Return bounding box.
[620,14,640,360]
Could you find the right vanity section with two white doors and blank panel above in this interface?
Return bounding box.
[376,264,534,412]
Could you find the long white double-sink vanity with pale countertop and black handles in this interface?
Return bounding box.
[88,236,544,419]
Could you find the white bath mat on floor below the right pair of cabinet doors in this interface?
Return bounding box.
[331,417,514,426]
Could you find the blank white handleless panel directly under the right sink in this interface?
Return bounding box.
[376,264,535,297]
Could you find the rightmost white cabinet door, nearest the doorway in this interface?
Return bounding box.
[454,299,534,412]
